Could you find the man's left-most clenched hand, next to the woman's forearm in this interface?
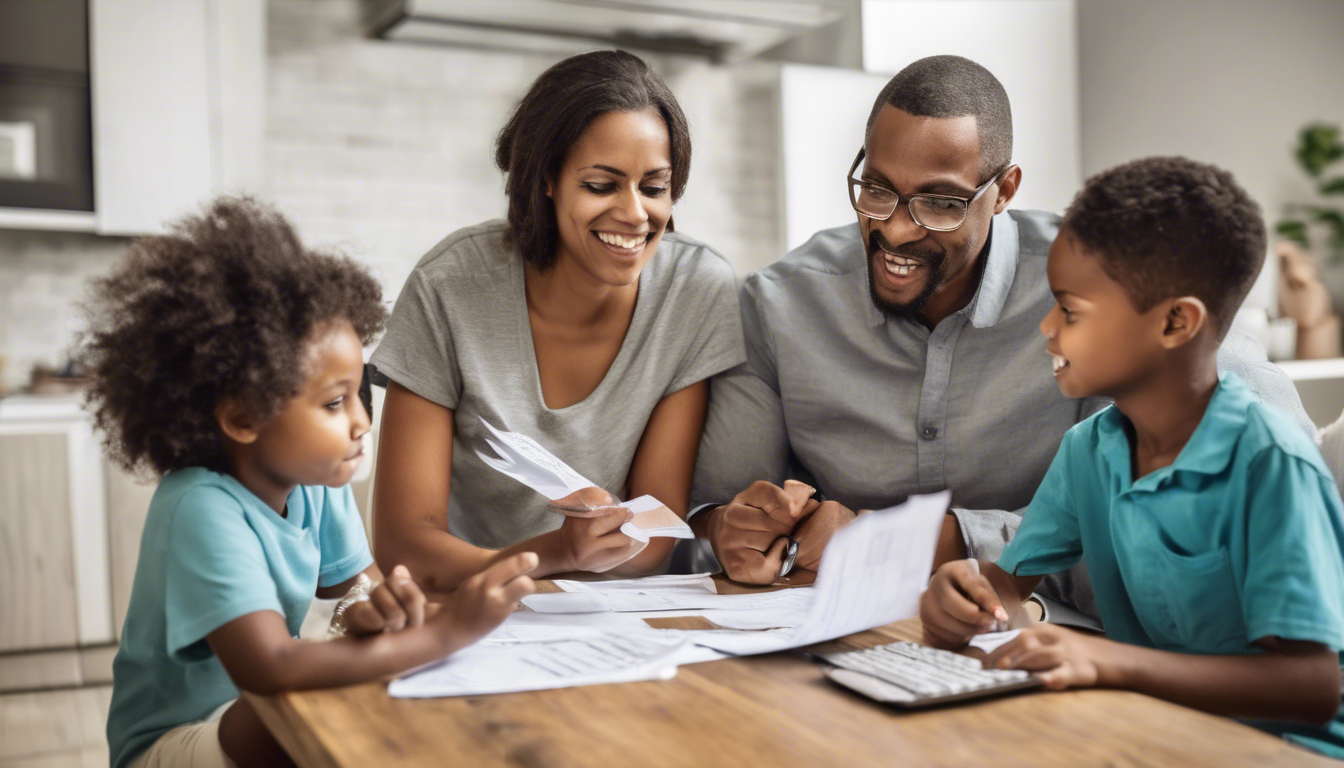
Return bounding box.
[706,480,812,584]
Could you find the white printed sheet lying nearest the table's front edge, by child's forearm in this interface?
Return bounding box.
[387,629,687,698]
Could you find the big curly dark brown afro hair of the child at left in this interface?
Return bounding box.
[81,198,387,475]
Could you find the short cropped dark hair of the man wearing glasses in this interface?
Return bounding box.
[867,55,1012,182]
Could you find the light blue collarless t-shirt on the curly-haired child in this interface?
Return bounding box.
[108,467,374,768]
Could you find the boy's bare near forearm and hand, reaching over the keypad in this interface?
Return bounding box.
[985,624,1340,724]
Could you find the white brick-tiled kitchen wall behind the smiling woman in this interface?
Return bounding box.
[0,0,782,386]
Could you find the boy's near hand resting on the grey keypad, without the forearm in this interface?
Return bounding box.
[984,624,1116,690]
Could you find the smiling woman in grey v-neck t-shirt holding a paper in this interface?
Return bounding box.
[372,51,745,590]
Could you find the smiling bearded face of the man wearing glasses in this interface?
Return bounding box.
[855,105,1008,316]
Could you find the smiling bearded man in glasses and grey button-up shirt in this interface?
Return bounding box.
[691,56,1310,615]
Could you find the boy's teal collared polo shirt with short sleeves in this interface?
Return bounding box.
[999,374,1344,757]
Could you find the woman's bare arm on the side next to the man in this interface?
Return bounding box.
[612,381,710,576]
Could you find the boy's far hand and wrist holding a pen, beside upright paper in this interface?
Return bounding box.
[919,560,1042,648]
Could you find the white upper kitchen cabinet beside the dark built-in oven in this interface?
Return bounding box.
[0,0,266,235]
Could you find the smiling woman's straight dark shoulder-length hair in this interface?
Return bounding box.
[495,51,691,269]
